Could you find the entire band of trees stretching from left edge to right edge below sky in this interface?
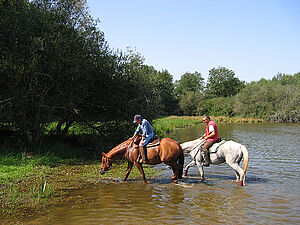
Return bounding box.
[0,0,300,145]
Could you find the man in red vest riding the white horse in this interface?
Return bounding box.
[200,115,219,166]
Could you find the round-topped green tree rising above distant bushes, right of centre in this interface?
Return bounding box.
[206,67,245,98]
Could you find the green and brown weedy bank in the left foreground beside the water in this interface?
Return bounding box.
[0,149,158,224]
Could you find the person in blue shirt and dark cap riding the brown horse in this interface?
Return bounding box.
[132,115,154,163]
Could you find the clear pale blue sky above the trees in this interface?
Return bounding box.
[87,0,300,82]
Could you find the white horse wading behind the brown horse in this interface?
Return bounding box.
[181,139,249,186]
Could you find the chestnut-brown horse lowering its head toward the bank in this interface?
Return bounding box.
[100,138,184,183]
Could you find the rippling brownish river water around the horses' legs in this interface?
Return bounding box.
[28,123,300,225]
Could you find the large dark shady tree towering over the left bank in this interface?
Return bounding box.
[0,0,113,144]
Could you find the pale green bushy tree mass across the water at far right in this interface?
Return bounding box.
[234,74,300,122]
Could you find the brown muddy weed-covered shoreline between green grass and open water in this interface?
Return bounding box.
[0,161,159,224]
